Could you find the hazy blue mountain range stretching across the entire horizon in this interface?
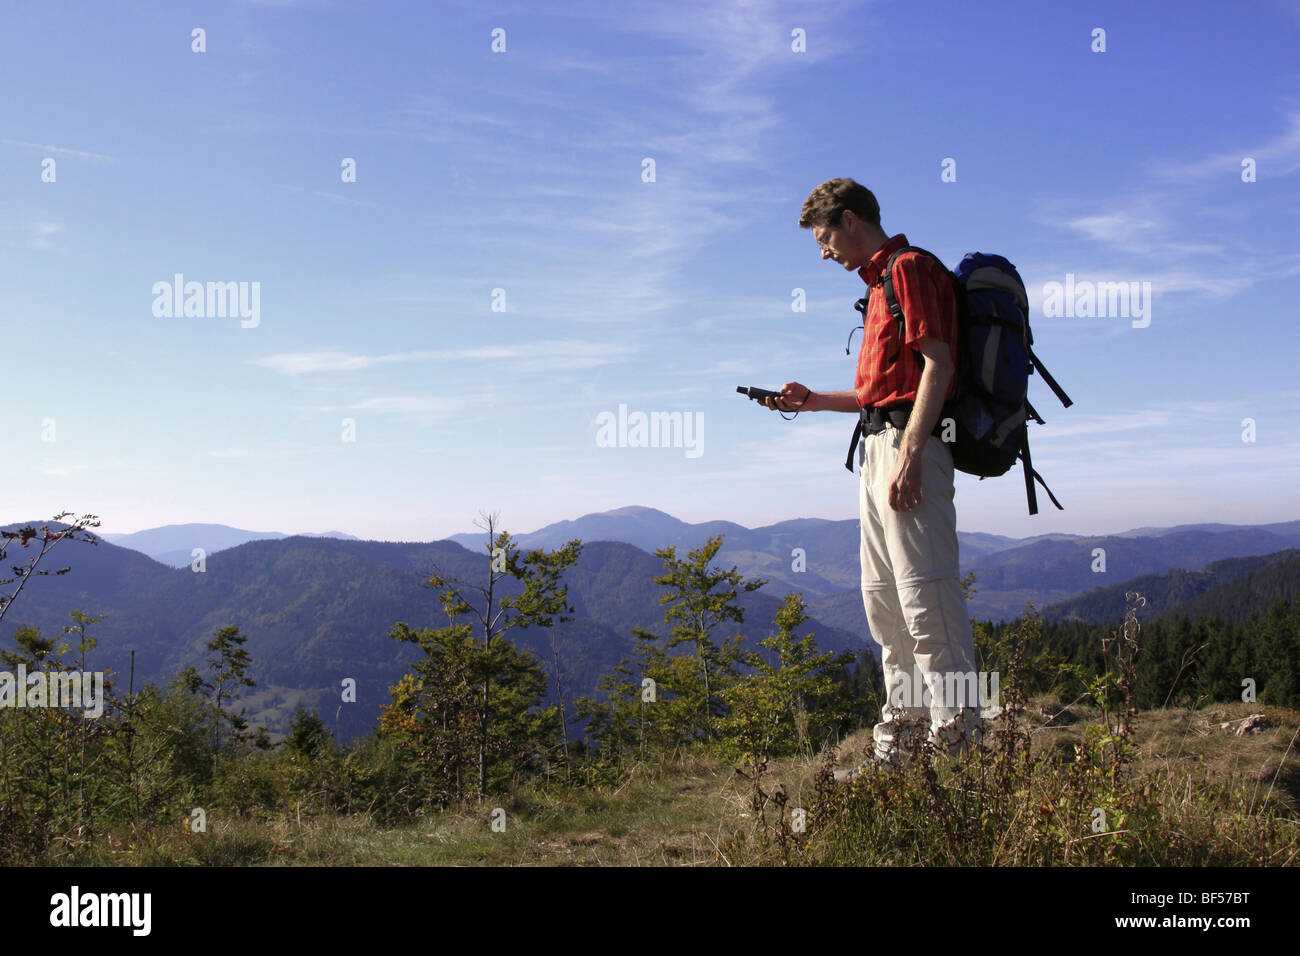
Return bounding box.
[0,507,1300,737]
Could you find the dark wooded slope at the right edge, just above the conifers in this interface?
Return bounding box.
[1043,549,1300,624]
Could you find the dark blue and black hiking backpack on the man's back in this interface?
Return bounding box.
[850,246,1074,515]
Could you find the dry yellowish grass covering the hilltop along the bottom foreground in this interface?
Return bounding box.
[43,700,1300,866]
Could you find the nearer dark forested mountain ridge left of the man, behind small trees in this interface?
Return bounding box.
[0,525,867,739]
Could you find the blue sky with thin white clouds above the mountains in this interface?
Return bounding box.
[0,0,1300,540]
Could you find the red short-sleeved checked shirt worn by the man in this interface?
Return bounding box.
[853,233,957,408]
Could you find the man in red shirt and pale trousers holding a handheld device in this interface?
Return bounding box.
[767,178,980,780]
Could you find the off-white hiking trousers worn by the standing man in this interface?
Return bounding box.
[859,424,980,756]
